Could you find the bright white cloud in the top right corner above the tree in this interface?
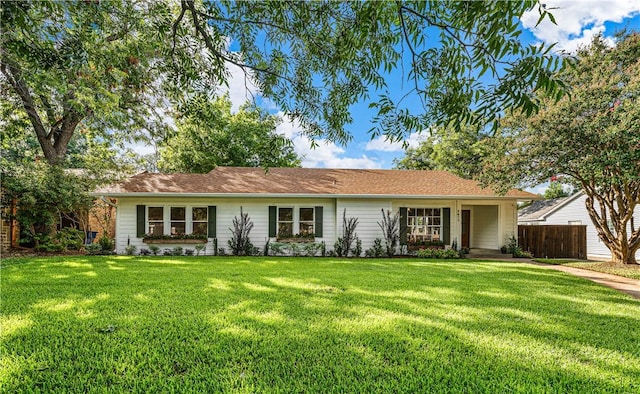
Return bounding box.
[521,0,640,52]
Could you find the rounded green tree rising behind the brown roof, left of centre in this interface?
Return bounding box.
[158,96,300,173]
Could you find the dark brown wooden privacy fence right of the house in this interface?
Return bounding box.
[518,225,587,260]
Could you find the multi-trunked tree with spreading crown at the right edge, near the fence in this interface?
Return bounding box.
[482,33,640,264]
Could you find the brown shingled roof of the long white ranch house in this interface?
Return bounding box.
[94,167,539,199]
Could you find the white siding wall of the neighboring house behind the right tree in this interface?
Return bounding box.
[540,195,640,258]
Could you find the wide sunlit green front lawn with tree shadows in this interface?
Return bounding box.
[0,256,640,393]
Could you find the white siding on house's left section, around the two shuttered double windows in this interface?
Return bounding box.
[116,197,335,254]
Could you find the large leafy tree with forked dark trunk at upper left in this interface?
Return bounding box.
[0,0,212,164]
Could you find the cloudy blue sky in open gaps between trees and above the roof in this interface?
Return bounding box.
[221,0,640,168]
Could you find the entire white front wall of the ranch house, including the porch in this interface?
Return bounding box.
[116,197,516,254]
